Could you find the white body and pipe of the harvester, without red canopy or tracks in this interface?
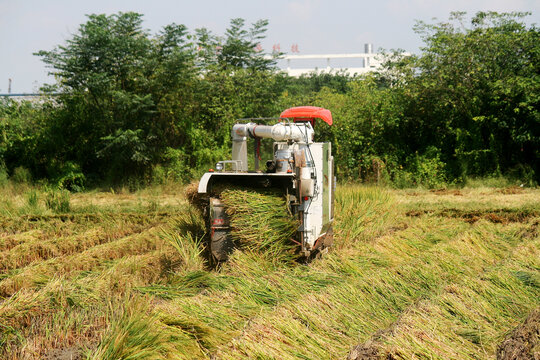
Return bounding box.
[198,116,335,256]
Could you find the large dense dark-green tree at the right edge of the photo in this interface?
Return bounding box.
[387,12,540,181]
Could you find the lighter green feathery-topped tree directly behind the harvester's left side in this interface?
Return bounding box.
[189,18,285,166]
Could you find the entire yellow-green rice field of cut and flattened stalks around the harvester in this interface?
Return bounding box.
[0,185,540,360]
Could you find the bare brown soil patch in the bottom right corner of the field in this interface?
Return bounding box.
[497,308,540,360]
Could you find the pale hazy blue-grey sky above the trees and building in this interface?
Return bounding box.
[0,0,540,93]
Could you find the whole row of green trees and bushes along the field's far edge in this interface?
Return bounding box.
[0,12,540,190]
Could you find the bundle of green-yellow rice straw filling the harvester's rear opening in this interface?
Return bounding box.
[221,190,299,261]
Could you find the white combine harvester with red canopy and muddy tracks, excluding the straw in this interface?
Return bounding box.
[198,106,335,261]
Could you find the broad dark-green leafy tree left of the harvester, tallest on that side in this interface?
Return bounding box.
[33,12,197,180]
